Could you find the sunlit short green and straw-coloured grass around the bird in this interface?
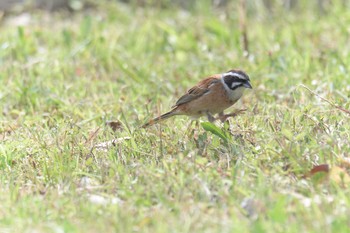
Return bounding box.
[0,1,350,232]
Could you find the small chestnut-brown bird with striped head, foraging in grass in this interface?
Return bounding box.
[142,70,252,128]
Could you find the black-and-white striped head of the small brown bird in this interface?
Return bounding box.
[222,70,252,90]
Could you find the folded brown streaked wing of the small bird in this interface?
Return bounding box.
[173,75,220,107]
